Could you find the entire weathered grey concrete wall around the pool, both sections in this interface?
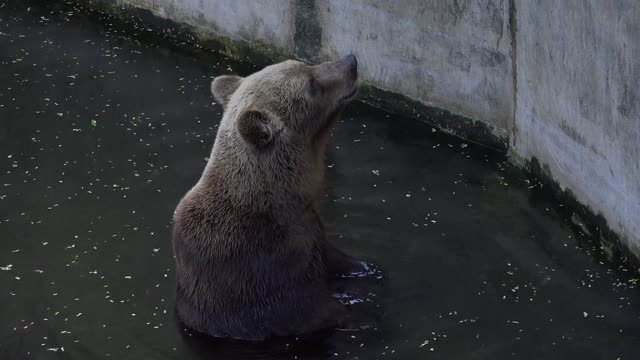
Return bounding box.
[104,0,640,256]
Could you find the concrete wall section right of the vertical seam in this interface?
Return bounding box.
[511,0,640,255]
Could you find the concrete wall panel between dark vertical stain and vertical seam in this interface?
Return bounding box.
[317,0,513,137]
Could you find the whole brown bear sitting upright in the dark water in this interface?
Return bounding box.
[173,55,368,340]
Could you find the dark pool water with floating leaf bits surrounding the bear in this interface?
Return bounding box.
[0,0,640,360]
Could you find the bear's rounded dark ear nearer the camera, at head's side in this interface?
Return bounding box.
[238,110,276,149]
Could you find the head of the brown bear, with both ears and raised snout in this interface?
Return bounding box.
[211,55,358,152]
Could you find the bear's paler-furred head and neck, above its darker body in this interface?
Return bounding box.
[209,55,358,202]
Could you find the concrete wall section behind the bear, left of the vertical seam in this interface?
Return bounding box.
[119,0,513,139]
